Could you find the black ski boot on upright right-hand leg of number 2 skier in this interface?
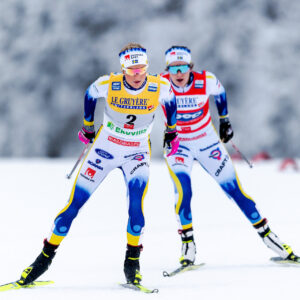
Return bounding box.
[124,245,143,284]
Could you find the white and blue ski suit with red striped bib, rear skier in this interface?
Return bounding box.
[163,71,262,230]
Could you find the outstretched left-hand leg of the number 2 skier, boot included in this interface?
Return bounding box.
[20,129,114,284]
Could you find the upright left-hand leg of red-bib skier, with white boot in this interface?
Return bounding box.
[166,145,196,265]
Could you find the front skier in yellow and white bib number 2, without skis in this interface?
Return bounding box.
[18,43,179,285]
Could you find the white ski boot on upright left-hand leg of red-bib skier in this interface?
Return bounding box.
[178,228,196,267]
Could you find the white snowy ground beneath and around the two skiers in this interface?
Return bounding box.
[0,160,300,300]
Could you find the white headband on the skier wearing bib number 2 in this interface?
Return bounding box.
[119,48,148,69]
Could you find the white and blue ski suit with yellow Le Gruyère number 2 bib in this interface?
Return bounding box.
[48,74,176,246]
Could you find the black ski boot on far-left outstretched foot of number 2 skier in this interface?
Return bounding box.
[18,239,58,285]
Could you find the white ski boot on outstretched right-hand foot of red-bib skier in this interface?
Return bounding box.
[254,219,300,264]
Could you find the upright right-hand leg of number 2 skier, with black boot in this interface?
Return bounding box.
[122,150,150,284]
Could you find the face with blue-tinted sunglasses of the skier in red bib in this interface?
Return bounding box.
[168,61,191,87]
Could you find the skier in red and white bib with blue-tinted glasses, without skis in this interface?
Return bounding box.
[163,46,300,266]
